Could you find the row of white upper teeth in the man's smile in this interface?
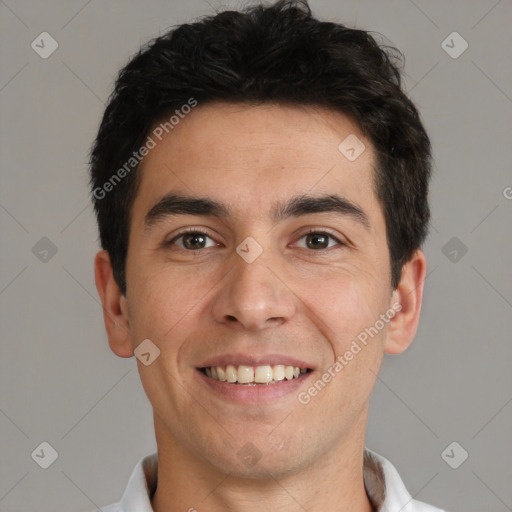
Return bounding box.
[205,364,307,384]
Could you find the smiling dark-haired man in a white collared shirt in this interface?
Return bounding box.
[91,1,446,512]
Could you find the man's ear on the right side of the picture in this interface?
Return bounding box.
[384,249,427,354]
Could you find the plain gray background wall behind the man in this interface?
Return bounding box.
[0,0,512,512]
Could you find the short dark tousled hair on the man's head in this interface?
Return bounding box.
[90,0,431,294]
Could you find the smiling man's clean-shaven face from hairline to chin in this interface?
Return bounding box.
[122,104,394,476]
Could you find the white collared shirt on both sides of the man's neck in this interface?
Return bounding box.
[101,448,444,512]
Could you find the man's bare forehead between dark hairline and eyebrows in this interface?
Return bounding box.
[134,103,375,224]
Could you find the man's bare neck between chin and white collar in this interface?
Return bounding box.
[151,414,372,512]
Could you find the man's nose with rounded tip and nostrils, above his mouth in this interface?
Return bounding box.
[212,245,297,331]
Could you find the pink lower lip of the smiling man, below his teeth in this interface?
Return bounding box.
[196,370,314,404]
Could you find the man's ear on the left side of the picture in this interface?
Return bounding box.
[94,251,134,357]
